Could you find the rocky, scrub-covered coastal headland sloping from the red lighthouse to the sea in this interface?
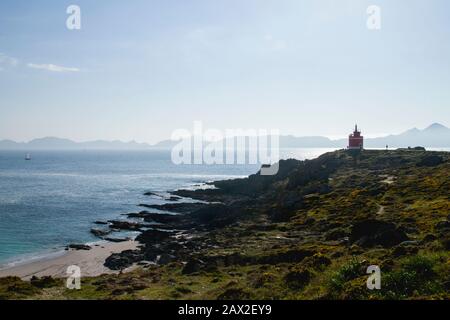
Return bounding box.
[0,149,450,299]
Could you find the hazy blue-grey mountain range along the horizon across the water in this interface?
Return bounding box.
[0,123,450,151]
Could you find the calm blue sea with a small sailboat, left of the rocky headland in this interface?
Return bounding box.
[0,149,336,265]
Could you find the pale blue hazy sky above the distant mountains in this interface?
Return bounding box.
[0,0,450,142]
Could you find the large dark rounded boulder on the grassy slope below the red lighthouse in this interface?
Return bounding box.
[350,220,409,248]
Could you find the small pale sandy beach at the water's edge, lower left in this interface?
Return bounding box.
[0,241,138,280]
